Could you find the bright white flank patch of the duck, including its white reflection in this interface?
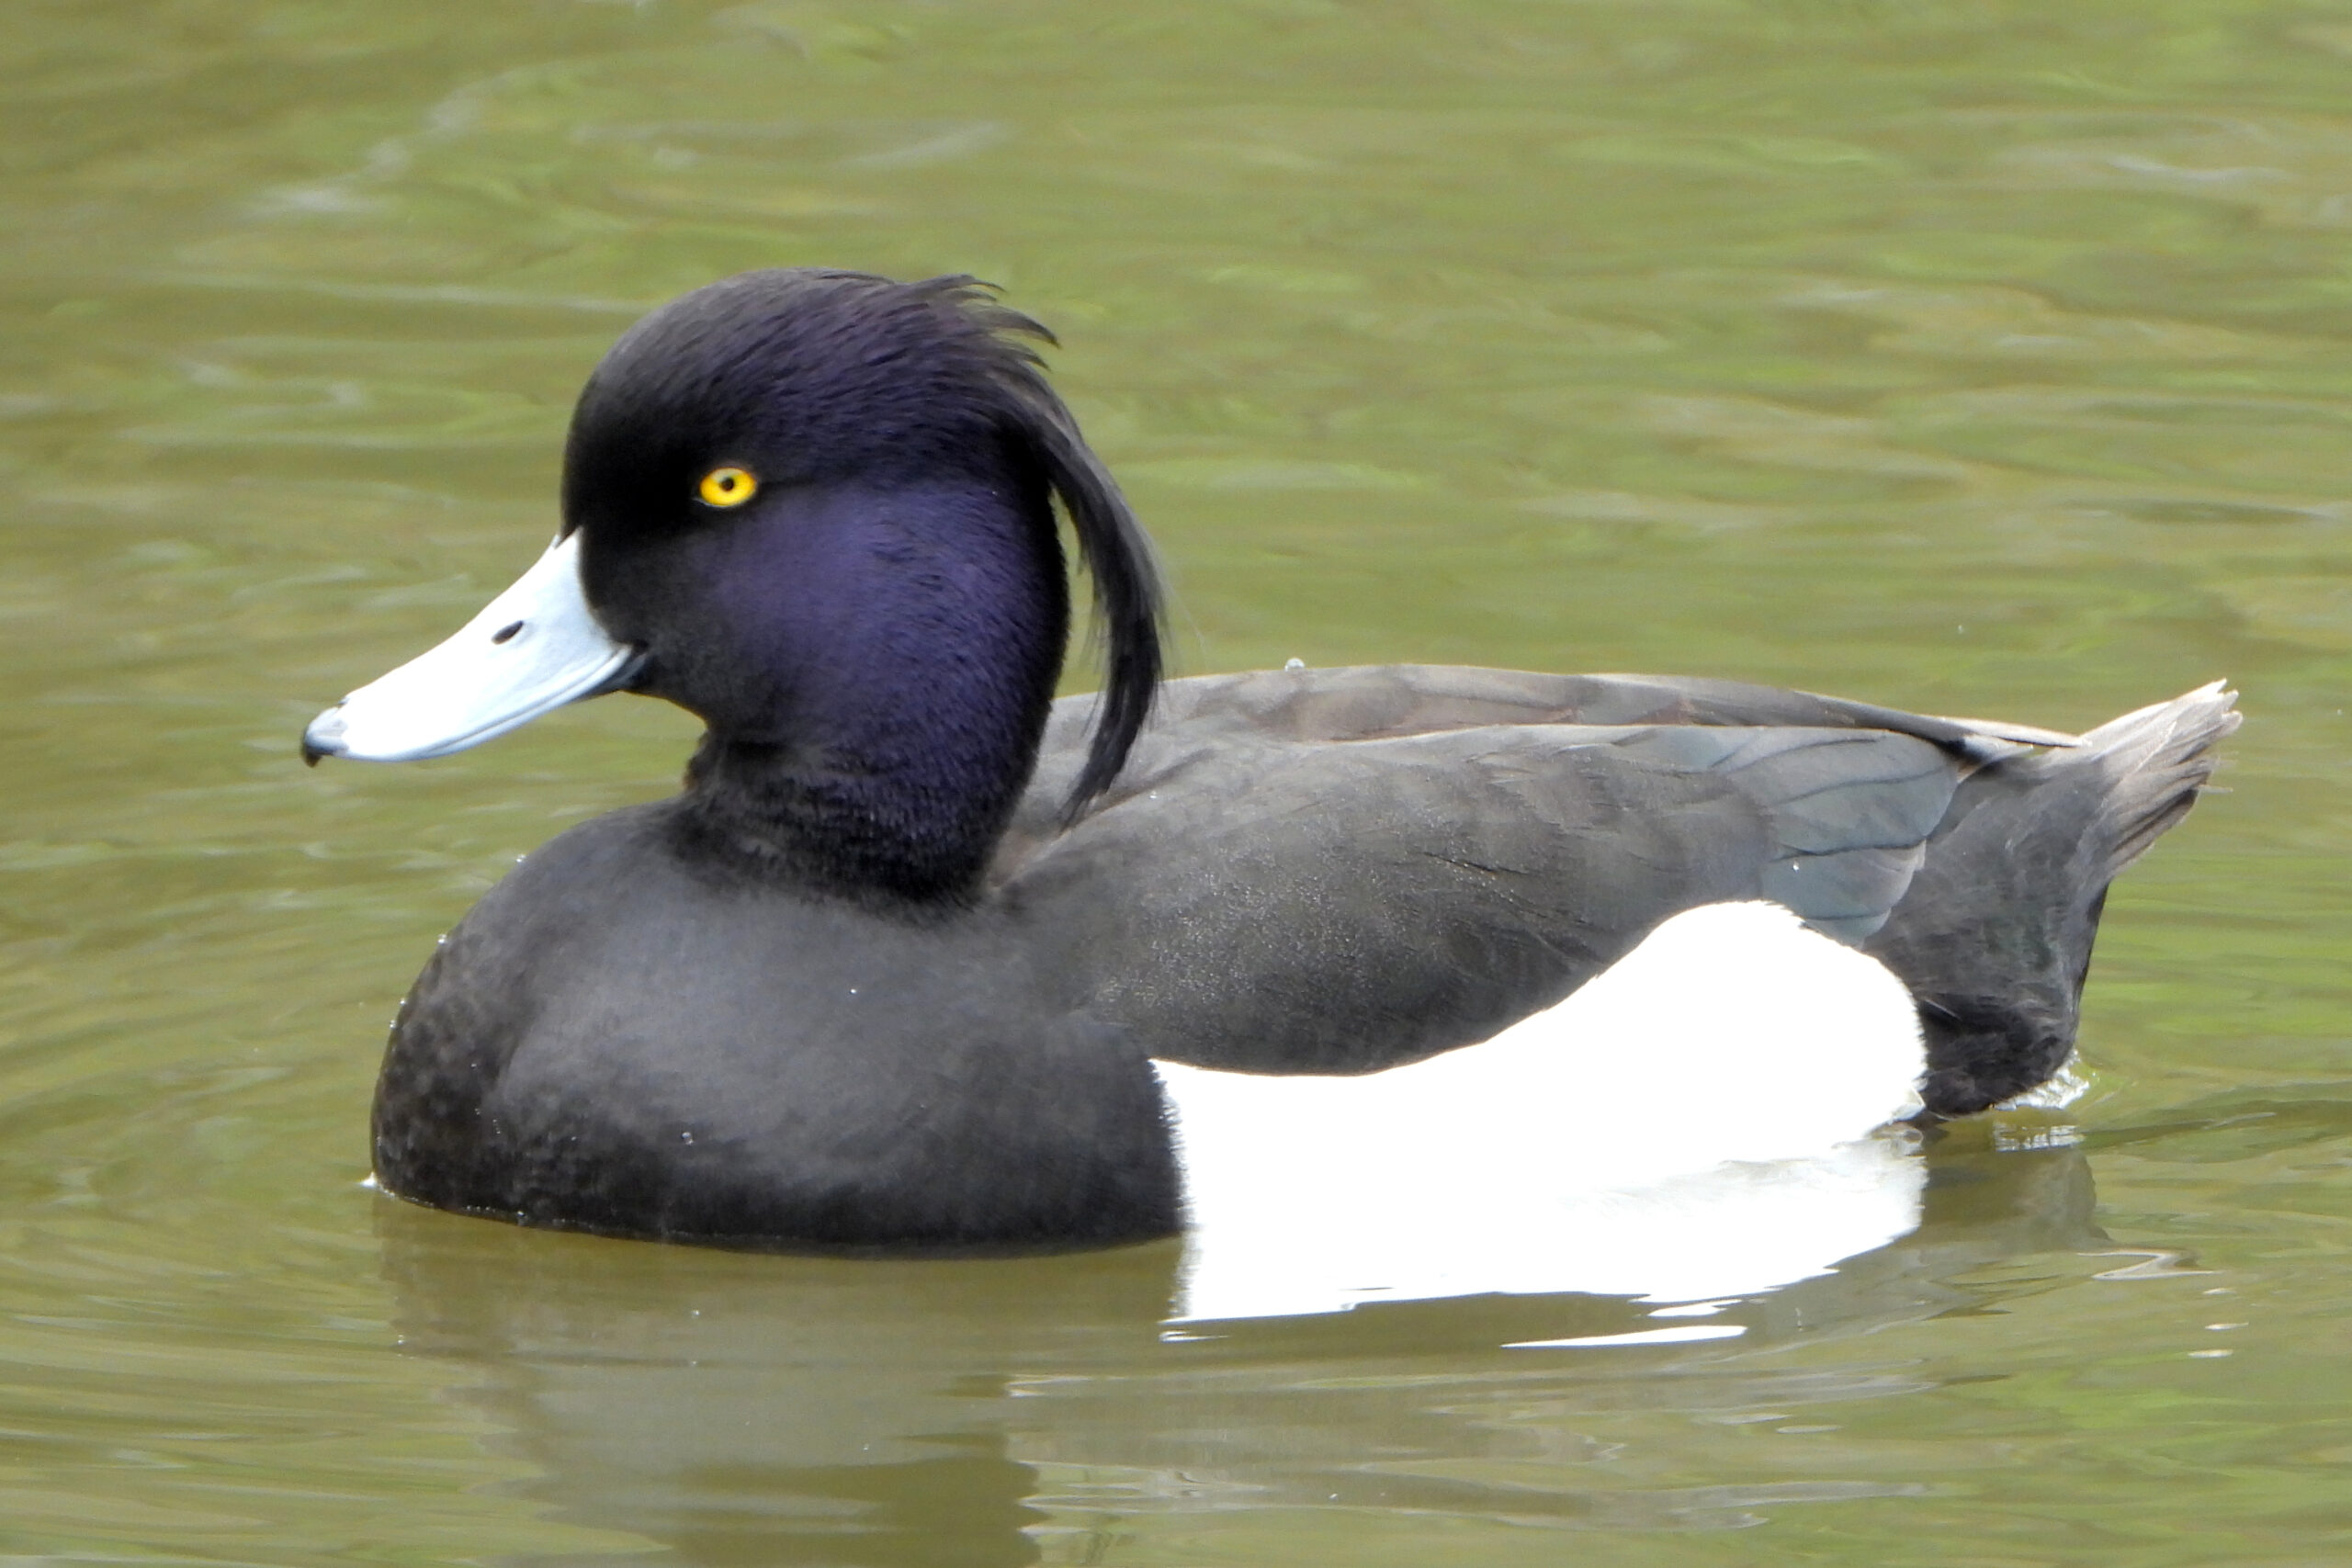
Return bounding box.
[1155,903,1927,1319]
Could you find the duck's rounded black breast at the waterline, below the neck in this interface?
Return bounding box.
[374,807,1176,1248]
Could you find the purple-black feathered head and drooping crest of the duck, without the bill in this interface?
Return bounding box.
[564,270,1159,851]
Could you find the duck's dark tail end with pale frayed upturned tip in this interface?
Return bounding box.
[1865,682,2239,1117]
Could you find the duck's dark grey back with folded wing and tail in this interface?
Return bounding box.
[997,665,2234,1112]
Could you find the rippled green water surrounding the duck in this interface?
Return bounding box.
[0,0,2352,1568]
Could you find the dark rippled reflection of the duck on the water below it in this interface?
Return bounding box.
[381,1134,2105,1568]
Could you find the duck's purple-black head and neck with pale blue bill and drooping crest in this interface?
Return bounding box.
[303,270,1159,896]
